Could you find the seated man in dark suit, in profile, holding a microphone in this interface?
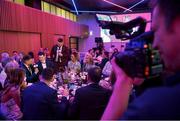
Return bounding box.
[21,55,39,83]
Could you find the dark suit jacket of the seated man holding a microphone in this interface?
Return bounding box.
[20,63,39,83]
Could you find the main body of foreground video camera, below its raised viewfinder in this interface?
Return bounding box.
[115,32,163,78]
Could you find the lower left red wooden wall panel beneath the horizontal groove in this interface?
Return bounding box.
[0,31,41,57]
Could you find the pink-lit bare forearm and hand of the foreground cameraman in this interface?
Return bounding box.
[101,58,133,120]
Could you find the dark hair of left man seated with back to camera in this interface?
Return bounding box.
[41,68,54,80]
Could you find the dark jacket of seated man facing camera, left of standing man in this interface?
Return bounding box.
[37,60,54,75]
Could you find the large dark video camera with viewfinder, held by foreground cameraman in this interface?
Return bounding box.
[96,14,163,79]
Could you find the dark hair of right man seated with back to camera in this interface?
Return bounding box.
[88,66,102,83]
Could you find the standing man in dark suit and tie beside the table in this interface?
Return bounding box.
[51,38,69,72]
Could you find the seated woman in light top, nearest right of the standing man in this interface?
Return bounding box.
[68,52,81,72]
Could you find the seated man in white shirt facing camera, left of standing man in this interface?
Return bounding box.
[37,52,54,74]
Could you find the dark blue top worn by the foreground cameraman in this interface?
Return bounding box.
[121,73,180,120]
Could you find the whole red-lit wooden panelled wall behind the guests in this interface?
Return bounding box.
[0,0,89,53]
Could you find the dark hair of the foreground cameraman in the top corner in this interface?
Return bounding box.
[151,0,180,28]
